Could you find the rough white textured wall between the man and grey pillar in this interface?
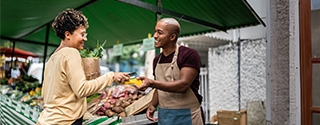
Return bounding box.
[208,39,266,116]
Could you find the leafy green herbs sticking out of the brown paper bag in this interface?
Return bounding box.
[79,41,107,58]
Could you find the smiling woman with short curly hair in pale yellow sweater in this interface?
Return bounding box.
[37,9,130,125]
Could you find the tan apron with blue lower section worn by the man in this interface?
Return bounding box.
[155,45,203,125]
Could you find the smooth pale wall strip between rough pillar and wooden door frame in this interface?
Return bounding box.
[289,0,301,125]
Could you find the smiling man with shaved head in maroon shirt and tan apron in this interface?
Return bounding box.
[138,18,204,125]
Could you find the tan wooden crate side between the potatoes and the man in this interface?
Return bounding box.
[125,89,155,116]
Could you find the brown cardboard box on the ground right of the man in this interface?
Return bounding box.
[217,110,247,125]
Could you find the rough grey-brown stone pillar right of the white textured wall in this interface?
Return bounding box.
[267,0,290,125]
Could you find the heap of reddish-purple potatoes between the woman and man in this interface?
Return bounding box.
[88,84,144,117]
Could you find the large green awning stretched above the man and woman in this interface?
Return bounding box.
[0,0,265,55]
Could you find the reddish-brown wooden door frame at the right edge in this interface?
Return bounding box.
[300,0,320,125]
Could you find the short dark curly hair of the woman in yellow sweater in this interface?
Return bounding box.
[52,8,89,39]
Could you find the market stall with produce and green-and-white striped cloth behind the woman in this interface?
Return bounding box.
[0,80,154,125]
